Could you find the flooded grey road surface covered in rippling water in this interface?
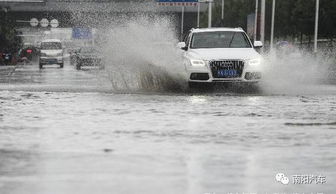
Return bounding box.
[0,61,336,194]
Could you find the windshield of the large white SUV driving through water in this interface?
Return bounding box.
[190,31,252,49]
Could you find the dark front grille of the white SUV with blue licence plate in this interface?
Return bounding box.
[209,60,244,78]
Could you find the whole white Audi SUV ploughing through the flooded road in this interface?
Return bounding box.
[178,28,262,86]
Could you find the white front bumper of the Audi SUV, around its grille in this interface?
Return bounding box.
[186,66,263,83]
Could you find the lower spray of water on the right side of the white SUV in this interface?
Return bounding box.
[261,49,334,94]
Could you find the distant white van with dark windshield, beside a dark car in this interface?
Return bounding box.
[39,39,64,69]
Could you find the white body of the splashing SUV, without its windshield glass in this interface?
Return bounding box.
[179,28,263,82]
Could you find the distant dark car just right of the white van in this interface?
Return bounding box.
[75,47,104,70]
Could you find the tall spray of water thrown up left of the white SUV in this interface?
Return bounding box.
[103,16,186,91]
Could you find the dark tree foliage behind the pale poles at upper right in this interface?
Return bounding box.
[201,0,336,39]
